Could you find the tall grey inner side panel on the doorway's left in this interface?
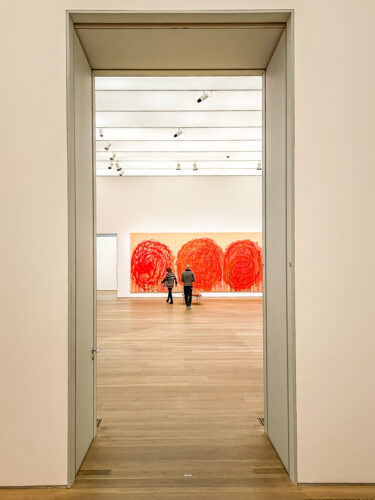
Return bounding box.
[69,27,96,484]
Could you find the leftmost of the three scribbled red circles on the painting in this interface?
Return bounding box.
[131,240,173,292]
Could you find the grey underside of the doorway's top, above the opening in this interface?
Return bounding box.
[76,22,284,71]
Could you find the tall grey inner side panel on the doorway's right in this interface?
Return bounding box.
[263,26,296,479]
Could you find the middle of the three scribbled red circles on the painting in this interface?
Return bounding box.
[177,238,224,292]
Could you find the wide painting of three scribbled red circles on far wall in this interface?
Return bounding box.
[130,233,263,293]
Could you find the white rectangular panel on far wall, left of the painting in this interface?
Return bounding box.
[96,234,117,290]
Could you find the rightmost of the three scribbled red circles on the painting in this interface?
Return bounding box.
[224,240,263,292]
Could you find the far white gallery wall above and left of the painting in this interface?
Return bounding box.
[96,176,262,297]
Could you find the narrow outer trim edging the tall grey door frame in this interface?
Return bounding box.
[66,9,298,486]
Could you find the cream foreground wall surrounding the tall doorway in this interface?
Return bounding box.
[0,0,375,485]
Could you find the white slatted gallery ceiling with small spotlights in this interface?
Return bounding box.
[95,76,262,176]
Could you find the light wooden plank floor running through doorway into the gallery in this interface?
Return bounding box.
[0,294,375,500]
